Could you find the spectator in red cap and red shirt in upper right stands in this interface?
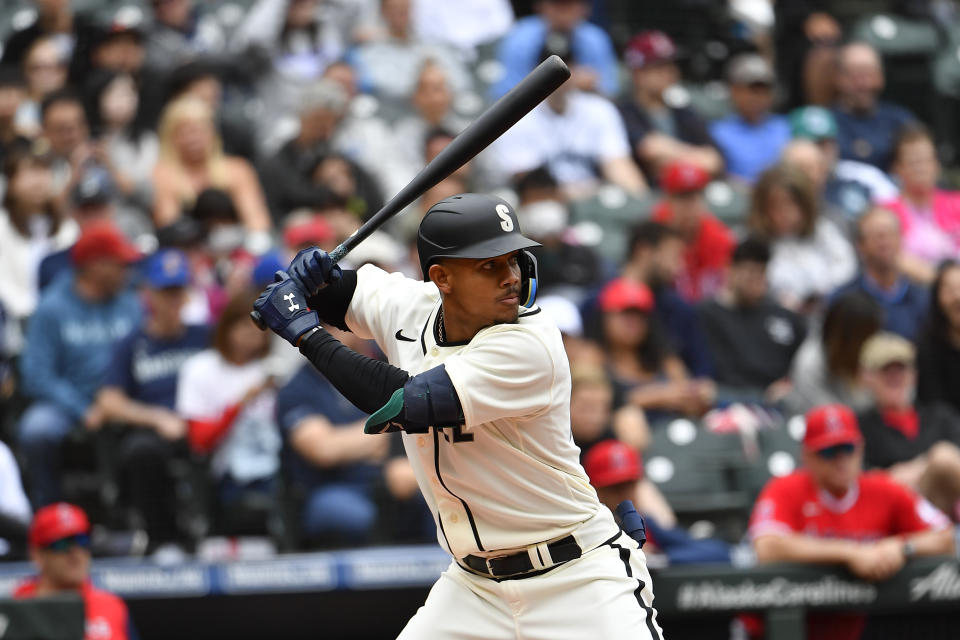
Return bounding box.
[652,160,736,302]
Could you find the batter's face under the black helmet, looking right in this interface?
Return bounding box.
[438,251,520,328]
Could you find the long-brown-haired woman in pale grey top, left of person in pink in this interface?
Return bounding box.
[747,165,857,312]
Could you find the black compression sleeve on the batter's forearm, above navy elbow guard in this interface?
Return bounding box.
[300,328,410,413]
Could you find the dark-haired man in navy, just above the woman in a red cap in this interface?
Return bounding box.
[621,221,713,378]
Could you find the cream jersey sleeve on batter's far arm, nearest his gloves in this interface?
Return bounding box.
[346,264,430,345]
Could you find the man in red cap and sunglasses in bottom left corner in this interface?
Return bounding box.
[13,502,137,640]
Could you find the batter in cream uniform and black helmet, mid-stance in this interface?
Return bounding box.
[254,194,662,640]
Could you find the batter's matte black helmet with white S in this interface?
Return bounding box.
[417,193,540,307]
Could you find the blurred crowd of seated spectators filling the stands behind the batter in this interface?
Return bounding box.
[0,0,960,580]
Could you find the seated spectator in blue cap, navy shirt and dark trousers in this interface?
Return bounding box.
[97,249,210,548]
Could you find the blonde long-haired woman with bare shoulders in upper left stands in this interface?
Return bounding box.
[153,97,270,240]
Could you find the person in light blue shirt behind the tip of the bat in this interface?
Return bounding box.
[490,0,619,98]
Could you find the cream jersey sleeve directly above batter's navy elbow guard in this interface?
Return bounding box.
[444,325,557,430]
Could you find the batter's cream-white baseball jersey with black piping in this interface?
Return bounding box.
[346,265,618,558]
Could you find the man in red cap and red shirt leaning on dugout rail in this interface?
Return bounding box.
[750,405,954,640]
